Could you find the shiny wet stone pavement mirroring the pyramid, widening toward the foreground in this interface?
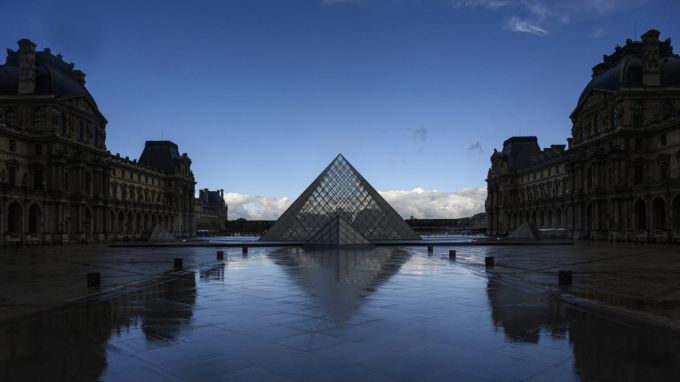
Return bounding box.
[0,248,680,382]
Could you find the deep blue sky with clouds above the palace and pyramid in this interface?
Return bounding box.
[0,0,680,218]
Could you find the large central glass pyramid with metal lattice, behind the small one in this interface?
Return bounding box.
[260,154,421,242]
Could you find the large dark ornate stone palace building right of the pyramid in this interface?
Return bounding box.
[486,30,680,242]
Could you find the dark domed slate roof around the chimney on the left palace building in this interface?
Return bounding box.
[0,48,97,108]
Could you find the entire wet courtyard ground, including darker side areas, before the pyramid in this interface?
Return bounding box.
[0,242,680,381]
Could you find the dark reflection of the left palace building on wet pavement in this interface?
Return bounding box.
[0,274,196,381]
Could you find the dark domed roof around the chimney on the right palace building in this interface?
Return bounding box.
[578,29,680,104]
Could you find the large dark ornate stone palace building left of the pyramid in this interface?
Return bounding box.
[0,39,196,245]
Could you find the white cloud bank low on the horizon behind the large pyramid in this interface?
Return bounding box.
[224,187,486,220]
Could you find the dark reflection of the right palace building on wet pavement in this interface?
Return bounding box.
[487,280,680,381]
